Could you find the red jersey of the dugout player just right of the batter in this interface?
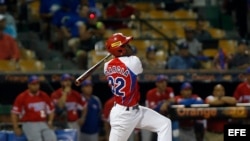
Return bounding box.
[146,87,174,109]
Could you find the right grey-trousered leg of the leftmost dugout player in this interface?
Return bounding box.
[39,122,57,141]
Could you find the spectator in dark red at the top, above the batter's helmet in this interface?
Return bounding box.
[106,0,139,30]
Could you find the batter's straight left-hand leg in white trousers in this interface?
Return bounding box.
[109,105,140,141]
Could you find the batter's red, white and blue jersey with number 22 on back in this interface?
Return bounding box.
[104,56,143,106]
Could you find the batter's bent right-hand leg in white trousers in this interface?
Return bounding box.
[136,106,172,141]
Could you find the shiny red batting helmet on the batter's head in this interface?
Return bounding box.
[106,33,133,57]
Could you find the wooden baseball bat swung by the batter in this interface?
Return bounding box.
[75,54,111,86]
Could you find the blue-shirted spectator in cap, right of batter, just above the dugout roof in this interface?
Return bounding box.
[167,43,199,70]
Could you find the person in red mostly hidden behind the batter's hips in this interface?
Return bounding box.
[102,96,138,141]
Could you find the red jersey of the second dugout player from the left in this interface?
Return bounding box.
[51,88,86,121]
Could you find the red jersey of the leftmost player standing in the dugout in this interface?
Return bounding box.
[11,90,54,122]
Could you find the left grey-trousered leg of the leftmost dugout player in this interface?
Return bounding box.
[22,122,43,141]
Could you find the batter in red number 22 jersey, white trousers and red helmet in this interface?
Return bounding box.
[104,33,172,141]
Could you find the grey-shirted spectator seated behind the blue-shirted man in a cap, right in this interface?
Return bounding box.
[176,27,203,57]
